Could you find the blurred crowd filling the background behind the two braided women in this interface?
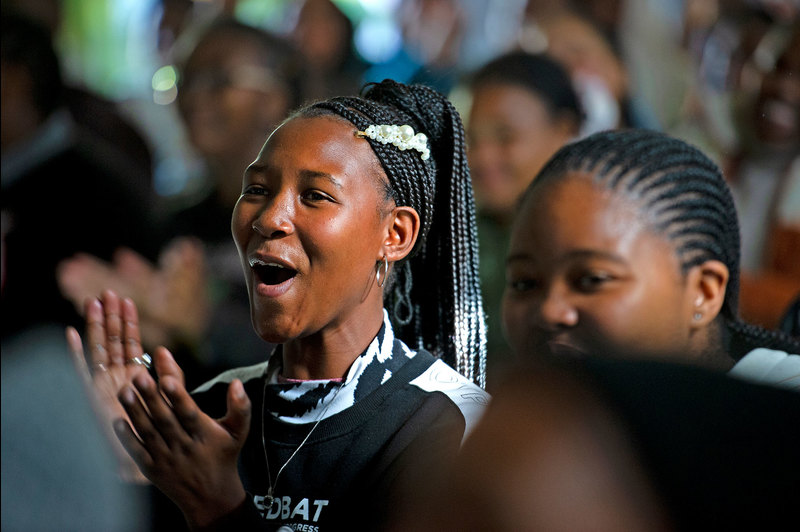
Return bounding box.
[0,0,800,523]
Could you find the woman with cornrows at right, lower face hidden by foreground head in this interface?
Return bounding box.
[503,129,800,391]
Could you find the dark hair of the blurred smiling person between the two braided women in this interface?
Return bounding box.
[469,51,584,129]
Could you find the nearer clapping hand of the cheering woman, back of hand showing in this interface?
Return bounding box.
[114,348,251,528]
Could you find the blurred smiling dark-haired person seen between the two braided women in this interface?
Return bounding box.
[467,51,583,390]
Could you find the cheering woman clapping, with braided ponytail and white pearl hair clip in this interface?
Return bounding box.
[68,80,489,531]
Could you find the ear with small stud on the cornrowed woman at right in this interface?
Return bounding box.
[687,260,730,329]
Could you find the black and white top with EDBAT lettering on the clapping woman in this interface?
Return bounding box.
[193,311,489,531]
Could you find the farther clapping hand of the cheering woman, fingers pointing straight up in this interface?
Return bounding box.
[67,290,183,482]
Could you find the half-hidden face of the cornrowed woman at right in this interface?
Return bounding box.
[503,173,694,359]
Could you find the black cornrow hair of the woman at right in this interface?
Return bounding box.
[525,129,800,360]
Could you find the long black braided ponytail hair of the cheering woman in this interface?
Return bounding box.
[290,79,486,387]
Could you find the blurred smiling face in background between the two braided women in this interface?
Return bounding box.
[467,83,573,215]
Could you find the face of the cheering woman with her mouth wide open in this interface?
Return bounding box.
[231,116,387,343]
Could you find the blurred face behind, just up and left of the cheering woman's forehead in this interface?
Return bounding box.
[178,33,289,165]
